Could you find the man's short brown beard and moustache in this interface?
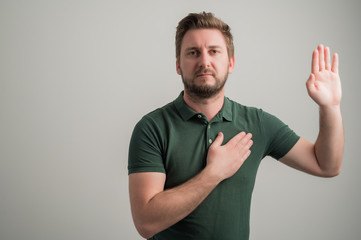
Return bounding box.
[181,69,228,99]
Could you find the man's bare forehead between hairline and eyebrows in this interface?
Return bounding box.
[181,29,226,50]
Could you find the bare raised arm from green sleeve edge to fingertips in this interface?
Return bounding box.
[280,45,344,177]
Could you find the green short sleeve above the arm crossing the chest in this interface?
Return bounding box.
[128,116,165,174]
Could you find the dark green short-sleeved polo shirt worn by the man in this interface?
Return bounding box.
[128,93,299,240]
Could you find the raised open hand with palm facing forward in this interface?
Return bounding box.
[306,44,342,107]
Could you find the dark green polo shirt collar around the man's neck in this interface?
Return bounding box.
[174,91,232,122]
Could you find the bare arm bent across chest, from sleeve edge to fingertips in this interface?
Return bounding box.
[129,132,253,238]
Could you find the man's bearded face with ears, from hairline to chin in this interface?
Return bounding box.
[177,29,234,99]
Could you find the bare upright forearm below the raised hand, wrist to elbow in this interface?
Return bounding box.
[315,105,344,176]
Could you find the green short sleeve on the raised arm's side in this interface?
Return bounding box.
[262,111,300,160]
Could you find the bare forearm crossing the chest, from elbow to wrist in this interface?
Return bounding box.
[134,168,220,238]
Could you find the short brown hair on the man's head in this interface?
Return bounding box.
[175,12,234,61]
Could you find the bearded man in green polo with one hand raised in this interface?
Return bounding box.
[128,12,344,240]
